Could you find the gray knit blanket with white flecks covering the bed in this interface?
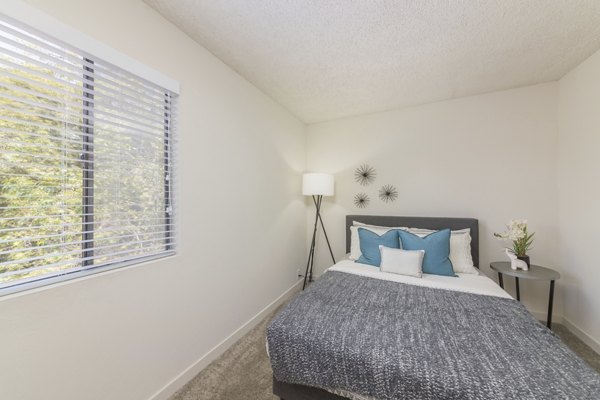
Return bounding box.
[267,271,600,400]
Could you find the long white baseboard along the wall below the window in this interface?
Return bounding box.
[149,280,302,400]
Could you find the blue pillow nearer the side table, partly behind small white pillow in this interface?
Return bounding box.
[398,229,456,276]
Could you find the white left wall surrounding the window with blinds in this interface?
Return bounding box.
[0,0,306,400]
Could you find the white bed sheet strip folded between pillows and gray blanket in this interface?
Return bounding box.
[327,259,512,299]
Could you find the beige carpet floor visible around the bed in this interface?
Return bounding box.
[171,306,600,400]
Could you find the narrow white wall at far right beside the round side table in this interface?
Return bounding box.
[558,47,600,351]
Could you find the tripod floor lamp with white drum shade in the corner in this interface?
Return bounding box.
[302,173,335,290]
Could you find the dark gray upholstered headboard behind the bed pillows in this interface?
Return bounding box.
[346,215,479,268]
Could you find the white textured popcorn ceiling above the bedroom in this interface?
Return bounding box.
[144,0,600,123]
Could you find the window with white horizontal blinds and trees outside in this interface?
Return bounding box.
[0,16,176,293]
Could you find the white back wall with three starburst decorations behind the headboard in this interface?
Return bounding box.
[307,83,561,315]
